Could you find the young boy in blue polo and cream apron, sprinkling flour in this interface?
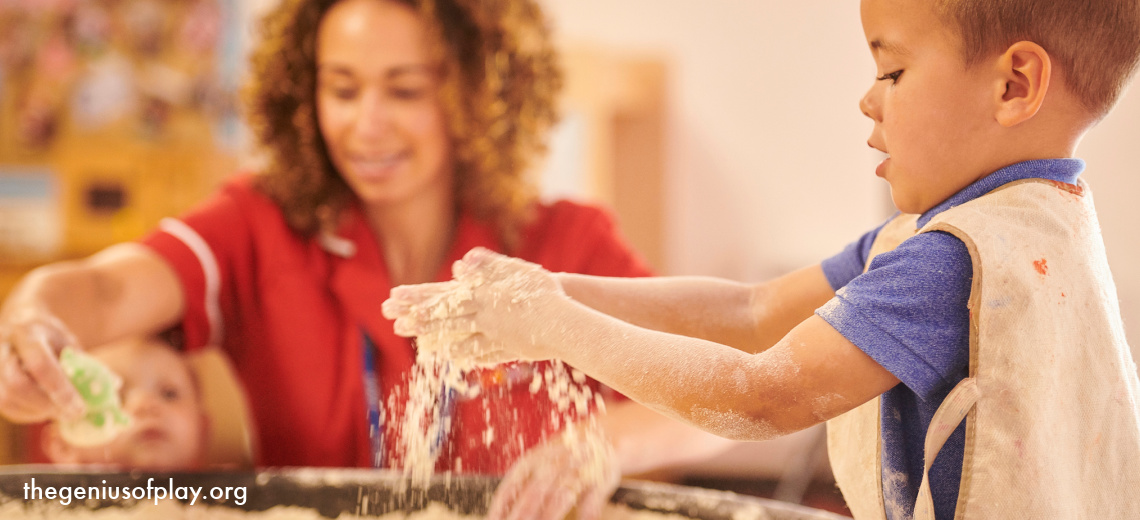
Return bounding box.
[385,0,1140,520]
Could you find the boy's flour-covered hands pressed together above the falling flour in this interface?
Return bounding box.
[383,247,568,364]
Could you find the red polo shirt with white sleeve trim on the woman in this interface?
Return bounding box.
[143,176,650,473]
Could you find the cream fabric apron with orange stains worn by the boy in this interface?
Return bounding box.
[828,179,1140,520]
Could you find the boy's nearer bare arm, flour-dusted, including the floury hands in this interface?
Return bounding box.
[384,250,898,440]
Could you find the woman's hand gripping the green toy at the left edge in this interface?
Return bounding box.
[0,307,86,423]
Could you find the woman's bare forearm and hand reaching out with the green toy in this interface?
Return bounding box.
[0,244,182,423]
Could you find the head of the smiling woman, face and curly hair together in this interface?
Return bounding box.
[247,0,562,254]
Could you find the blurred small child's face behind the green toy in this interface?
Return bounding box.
[43,339,207,471]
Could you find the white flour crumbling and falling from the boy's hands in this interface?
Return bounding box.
[388,260,609,488]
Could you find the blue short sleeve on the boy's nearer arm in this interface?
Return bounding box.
[816,231,974,400]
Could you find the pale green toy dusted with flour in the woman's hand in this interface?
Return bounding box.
[59,347,130,446]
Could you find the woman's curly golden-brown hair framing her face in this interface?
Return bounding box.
[245,0,562,249]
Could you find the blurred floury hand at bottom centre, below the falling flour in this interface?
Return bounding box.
[487,426,621,520]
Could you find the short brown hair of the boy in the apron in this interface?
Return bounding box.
[934,0,1140,119]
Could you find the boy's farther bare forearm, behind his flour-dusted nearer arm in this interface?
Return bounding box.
[554,265,834,352]
